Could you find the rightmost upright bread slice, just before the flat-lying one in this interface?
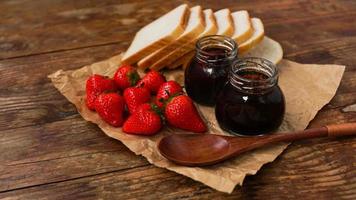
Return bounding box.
[238,18,265,55]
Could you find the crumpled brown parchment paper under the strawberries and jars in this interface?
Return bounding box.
[49,55,345,193]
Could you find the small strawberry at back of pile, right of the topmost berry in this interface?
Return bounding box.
[137,70,166,94]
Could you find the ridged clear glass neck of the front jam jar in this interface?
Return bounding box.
[229,57,278,94]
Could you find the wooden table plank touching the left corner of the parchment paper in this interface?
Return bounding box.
[0,44,122,130]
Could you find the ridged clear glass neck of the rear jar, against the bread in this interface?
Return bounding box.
[195,35,237,65]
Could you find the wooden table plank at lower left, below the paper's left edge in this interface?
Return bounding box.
[0,116,148,192]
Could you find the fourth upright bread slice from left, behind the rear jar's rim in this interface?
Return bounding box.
[214,8,234,37]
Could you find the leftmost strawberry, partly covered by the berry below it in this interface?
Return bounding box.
[86,74,117,110]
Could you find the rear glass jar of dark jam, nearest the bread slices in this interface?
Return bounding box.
[184,35,237,106]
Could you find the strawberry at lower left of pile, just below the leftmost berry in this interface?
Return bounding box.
[95,93,125,127]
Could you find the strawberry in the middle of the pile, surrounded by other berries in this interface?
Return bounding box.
[124,87,151,114]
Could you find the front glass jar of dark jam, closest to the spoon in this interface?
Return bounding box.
[215,58,285,135]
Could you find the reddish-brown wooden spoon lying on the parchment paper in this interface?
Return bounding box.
[158,123,356,166]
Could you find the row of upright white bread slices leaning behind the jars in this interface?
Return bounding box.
[122,4,270,70]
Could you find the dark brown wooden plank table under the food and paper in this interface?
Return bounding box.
[0,0,356,199]
